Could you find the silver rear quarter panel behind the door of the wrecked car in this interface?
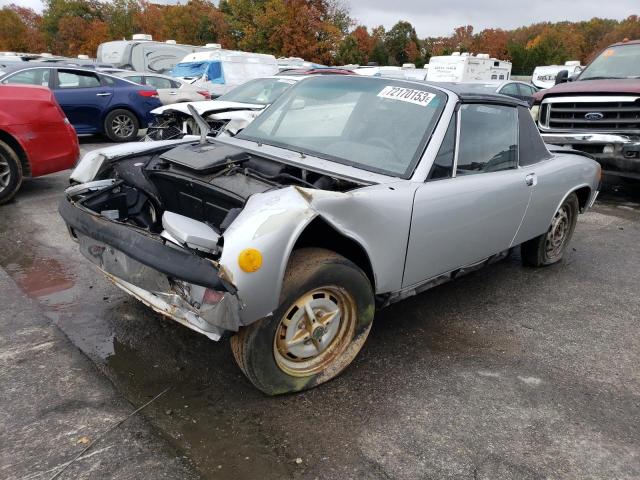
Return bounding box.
[513,153,600,246]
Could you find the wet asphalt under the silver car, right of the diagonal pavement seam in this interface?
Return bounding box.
[0,139,640,480]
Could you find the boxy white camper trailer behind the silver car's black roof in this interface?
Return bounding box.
[427,52,511,82]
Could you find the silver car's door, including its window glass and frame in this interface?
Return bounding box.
[403,104,535,287]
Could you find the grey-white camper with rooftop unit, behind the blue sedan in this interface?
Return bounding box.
[97,33,210,73]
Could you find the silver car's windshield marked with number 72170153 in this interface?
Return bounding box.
[238,76,447,178]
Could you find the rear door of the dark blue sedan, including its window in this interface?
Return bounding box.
[53,68,113,133]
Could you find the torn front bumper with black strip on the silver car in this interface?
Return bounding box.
[59,198,241,340]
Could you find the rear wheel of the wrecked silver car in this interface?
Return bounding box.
[521,193,579,267]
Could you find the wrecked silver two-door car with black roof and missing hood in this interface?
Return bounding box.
[60,76,600,394]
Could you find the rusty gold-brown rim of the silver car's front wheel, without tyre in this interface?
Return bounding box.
[273,286,356,377]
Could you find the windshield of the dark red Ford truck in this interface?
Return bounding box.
[578,43,640,80]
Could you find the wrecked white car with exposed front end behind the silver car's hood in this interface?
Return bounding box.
[145,76,303,140]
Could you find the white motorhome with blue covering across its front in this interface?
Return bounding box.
[169,48,278,97]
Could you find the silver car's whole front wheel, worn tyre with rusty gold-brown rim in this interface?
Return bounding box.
[231,248,375,395]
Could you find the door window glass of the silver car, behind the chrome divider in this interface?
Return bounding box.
[456,104,518,175]
